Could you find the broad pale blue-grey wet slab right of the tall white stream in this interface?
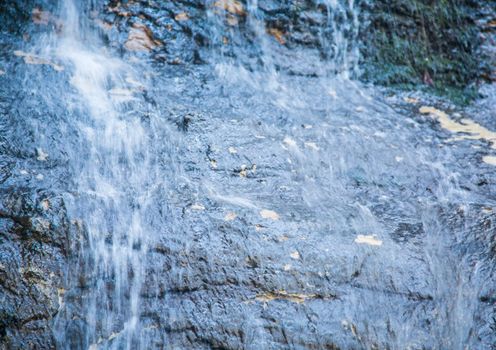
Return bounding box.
[131,69,494,349]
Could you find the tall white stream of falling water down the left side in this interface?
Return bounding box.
[49,0,167,349]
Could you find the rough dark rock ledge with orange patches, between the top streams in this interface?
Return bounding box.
[99,1,353,75]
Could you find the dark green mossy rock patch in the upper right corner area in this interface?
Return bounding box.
[362,0,479,103]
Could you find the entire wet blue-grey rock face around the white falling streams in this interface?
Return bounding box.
[0,0,496,349]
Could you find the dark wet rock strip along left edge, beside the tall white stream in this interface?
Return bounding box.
[0,56,71,349]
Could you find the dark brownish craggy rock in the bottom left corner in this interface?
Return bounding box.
[0,190,67,349]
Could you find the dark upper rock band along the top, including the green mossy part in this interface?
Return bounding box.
[98,0,496,102]
